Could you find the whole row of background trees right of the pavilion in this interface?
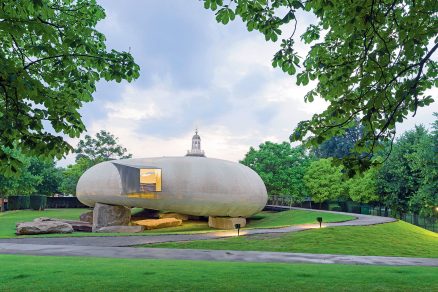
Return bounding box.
[241,114,438,216]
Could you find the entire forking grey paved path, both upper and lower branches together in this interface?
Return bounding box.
[0,208,428,266]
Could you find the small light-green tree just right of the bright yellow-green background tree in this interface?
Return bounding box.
[346,167,379,203]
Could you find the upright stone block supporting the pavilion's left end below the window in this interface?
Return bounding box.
[93,203,131,230]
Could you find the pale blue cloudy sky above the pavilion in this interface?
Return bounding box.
[60,0,438,165]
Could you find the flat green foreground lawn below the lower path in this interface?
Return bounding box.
[0,255,438,291]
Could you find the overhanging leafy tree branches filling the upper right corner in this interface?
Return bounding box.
[204,0,438,171]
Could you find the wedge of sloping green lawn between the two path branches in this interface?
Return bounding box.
[144,221,438,258]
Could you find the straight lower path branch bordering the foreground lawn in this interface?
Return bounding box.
[0,243,438,267]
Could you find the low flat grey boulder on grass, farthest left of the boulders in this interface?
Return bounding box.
[16,221,73,235]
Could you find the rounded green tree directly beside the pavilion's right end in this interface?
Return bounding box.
[240,141,310,202]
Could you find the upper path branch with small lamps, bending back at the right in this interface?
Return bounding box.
[0,208,396,246]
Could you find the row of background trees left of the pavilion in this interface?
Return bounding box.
[0,131,132,209]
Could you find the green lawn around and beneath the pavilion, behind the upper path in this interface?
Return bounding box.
[0,208,355,238]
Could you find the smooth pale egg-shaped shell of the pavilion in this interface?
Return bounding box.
[76,157,268,217]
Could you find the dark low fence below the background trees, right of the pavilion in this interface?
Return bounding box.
[267,196,438,232]
